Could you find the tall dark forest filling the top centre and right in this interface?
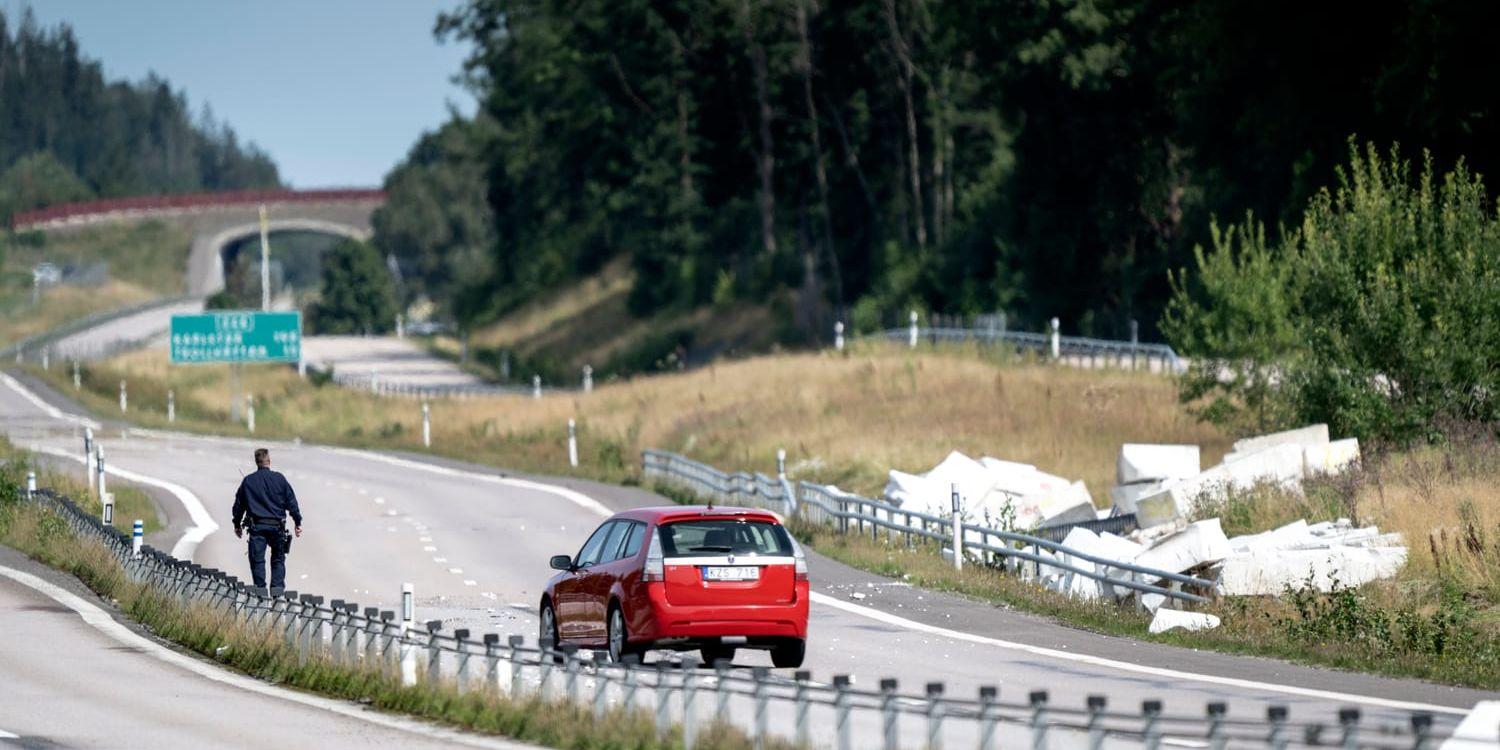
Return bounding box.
[377,0,1500,343]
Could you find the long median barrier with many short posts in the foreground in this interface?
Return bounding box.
[17,488,1442,750]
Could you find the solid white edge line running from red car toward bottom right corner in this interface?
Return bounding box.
[812,591,1469,716]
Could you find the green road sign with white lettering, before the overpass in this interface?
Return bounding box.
[173,311,302,365]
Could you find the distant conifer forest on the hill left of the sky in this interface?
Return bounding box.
[0,11,281,227]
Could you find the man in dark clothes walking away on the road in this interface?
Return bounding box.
[234,449,302,594]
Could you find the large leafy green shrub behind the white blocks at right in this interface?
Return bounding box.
[1163,146,1500,444]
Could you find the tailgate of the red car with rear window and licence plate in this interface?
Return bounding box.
[657,516,797,606]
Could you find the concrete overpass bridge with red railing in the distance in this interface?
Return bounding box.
[11,189,386,297]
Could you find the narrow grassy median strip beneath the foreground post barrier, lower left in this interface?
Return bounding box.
[0,441,792,750]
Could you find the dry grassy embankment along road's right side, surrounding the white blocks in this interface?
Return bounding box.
[26,345,1500,687]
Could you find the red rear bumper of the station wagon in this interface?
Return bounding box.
[632,584,809,648]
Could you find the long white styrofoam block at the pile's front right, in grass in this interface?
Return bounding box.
[1220,546,1407,596]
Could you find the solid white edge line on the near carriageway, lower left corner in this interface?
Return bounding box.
[0,566,536,750]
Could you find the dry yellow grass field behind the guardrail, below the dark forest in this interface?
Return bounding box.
[70,345,1229,501]
